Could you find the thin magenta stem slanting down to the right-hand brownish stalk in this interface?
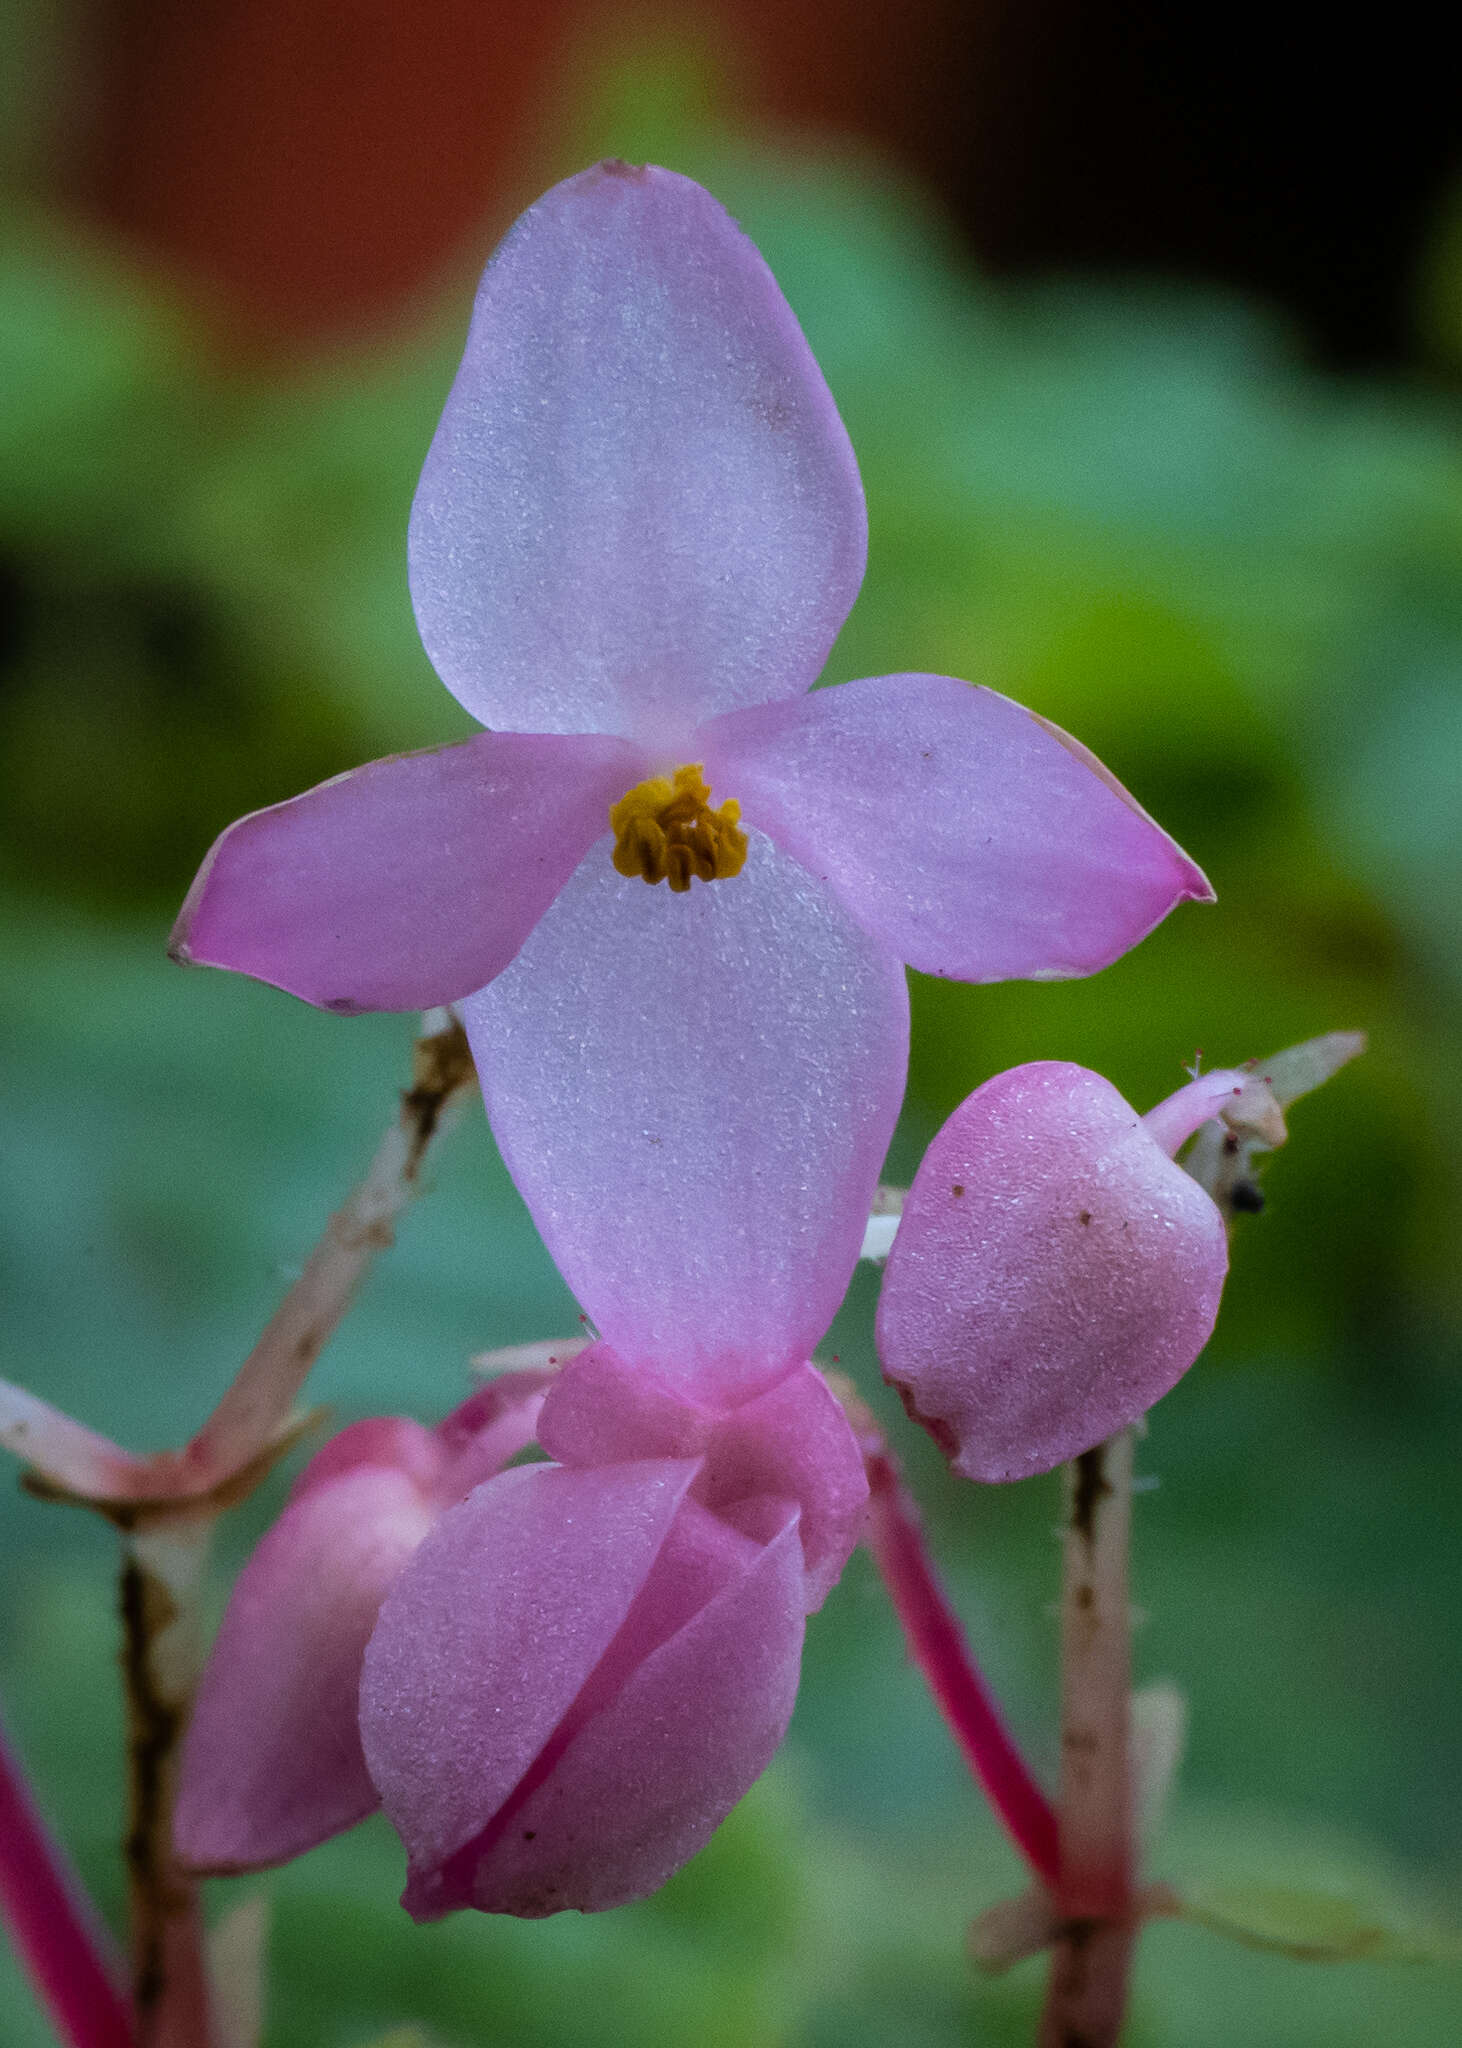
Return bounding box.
[864,1450,1061,1886]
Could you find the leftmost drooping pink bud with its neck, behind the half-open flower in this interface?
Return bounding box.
[174,1372,551,1872]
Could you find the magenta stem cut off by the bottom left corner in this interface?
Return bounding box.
[0,1729,135,2048]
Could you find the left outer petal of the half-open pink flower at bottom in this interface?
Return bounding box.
[360,1460,696,1870]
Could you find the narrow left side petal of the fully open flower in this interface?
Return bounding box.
[172,733,643,1012]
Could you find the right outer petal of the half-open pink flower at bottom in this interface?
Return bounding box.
[453,1511,803,1917]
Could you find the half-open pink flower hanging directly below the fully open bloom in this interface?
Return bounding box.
[360,1346,868,1919]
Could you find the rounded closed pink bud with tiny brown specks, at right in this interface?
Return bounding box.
[878,1061,1229,1479]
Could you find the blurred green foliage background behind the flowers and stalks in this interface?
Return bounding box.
[0,6,1462,2048]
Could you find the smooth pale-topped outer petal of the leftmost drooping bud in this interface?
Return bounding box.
[174,1464,434,1870]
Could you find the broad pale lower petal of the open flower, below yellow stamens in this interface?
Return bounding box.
[463,834,907,1391]
